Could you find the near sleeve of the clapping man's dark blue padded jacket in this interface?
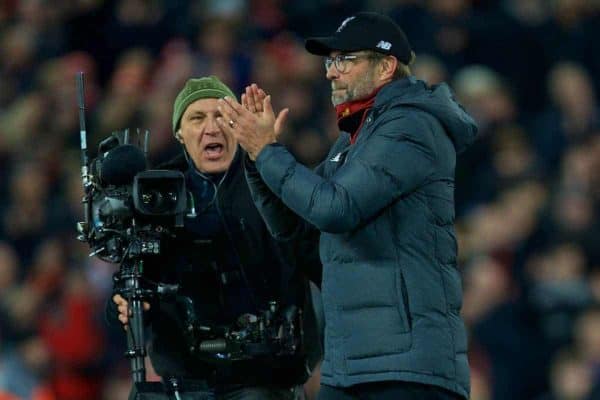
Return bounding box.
[256,113,435,233]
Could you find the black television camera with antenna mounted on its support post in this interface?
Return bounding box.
[76,72,182,383]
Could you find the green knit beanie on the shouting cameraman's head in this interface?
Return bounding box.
[173,75,236,133]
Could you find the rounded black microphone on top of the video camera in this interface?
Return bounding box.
[100,144,146,186]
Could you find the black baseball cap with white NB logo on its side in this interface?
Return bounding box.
[305,12,412,64]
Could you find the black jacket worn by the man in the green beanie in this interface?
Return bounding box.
[107,148,321,384]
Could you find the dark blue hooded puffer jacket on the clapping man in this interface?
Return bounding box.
[247,78,477,397]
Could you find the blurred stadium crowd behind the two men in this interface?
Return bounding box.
[0,0,600,400]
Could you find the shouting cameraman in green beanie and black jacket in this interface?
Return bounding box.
[107,76,320,399]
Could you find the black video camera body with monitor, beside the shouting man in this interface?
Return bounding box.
[78,131,187,263]
